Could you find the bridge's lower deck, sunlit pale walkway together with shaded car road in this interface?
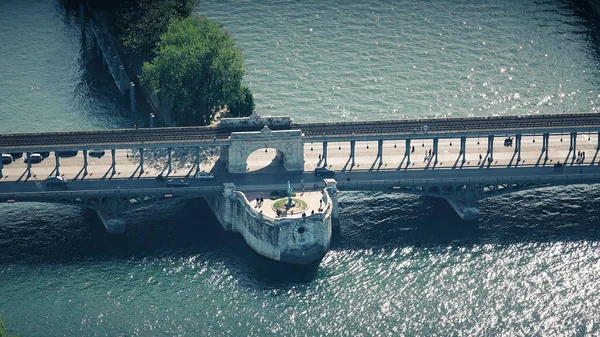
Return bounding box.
[0,134,599,194]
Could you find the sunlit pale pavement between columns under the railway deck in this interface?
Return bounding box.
[0,134,600,186]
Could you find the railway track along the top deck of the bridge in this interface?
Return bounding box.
[0,113,600,151]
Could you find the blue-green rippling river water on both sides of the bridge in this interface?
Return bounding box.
[0,0,600,336]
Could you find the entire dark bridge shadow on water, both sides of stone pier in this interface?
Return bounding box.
[0,186,600,288]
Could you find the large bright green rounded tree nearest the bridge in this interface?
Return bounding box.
[140,15,246,125]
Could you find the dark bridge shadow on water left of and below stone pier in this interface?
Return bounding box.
[0,199,318,288]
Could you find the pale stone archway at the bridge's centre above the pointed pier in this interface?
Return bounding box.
[227,126,304,173]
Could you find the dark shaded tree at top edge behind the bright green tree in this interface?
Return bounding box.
[112,0,198,59]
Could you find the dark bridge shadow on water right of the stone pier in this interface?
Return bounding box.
[332,186,600,250]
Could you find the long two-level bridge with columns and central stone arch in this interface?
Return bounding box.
[0,113,600,226]
